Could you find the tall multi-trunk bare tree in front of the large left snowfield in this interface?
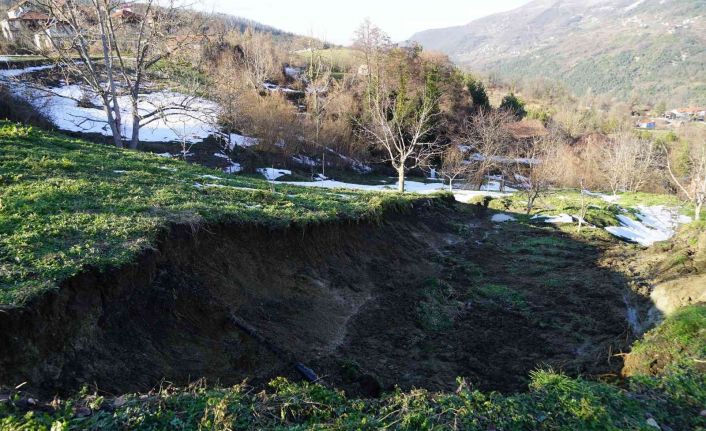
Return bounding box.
[38,0,202,149]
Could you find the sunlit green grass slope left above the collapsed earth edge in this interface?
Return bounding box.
[0,122,419,306]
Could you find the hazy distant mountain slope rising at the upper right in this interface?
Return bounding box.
[411,0,706,105]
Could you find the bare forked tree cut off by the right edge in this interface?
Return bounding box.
[665,134,706,221]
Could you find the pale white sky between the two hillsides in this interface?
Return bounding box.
[201,0,529,45]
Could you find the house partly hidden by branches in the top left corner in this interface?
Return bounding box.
[0,0,69,50]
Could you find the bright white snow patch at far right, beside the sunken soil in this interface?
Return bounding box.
[606,205,692,247]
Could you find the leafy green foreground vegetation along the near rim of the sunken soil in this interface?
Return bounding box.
[0,306,706,431]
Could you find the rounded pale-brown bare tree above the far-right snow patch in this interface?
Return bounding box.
[601,132,657,194]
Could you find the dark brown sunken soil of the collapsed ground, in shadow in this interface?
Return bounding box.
[0,203,632,395]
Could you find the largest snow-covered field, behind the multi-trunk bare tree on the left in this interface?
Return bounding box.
[0,66,218,142]
